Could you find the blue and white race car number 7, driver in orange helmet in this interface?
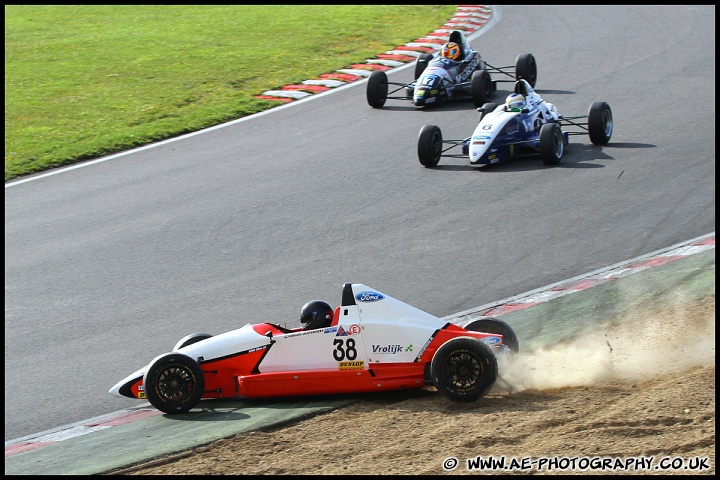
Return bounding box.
[366,30,537,108]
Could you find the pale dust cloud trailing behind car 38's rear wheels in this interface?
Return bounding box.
[498,297,715,392]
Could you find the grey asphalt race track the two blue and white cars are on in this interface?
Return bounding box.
[5,1,715,462]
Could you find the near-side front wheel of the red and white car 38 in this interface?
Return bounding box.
[143,352,205,415]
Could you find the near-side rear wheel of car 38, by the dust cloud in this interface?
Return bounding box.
[430,337,498,403]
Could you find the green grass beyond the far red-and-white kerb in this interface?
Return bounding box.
[5,5,457,182]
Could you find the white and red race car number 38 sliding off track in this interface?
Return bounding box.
[109,283,519,414]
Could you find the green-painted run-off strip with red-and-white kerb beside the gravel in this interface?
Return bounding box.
[5,233,715,475]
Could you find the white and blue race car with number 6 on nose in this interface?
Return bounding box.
[418,79,613,168]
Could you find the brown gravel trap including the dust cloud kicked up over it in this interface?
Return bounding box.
[107,296,716,476]
